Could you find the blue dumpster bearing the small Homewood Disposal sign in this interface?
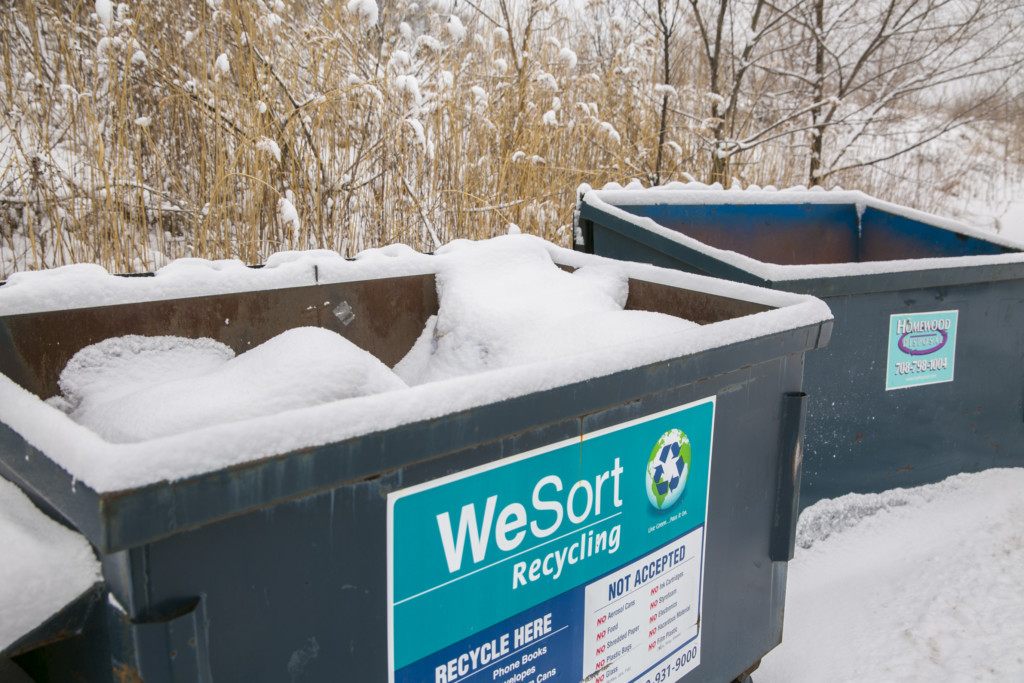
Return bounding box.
[577,183,1024,505]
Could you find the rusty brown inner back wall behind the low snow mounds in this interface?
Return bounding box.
[0,275,437,398]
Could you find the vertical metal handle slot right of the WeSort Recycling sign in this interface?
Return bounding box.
[768,392,807,562]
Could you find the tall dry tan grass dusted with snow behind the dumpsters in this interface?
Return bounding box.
[0,0,1019,278]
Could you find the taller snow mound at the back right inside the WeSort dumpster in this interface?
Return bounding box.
[394,236,696,385]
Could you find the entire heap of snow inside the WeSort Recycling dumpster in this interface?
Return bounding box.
[37,243,695,442]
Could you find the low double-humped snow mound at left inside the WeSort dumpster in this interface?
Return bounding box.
[60,328,406,442]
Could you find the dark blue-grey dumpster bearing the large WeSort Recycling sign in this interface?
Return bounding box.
[0,237,831,683]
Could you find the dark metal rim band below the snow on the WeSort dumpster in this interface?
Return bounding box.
[0,319,833,553]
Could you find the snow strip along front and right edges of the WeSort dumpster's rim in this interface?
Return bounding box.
[0,246,833,497]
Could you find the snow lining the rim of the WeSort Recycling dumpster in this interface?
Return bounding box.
[0,236,833,493]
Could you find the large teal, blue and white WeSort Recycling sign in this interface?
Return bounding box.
[387,396,715,683]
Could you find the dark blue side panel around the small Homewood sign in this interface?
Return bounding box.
[801,280,1024,506]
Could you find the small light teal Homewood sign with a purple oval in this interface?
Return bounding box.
[886,310,958,391]
